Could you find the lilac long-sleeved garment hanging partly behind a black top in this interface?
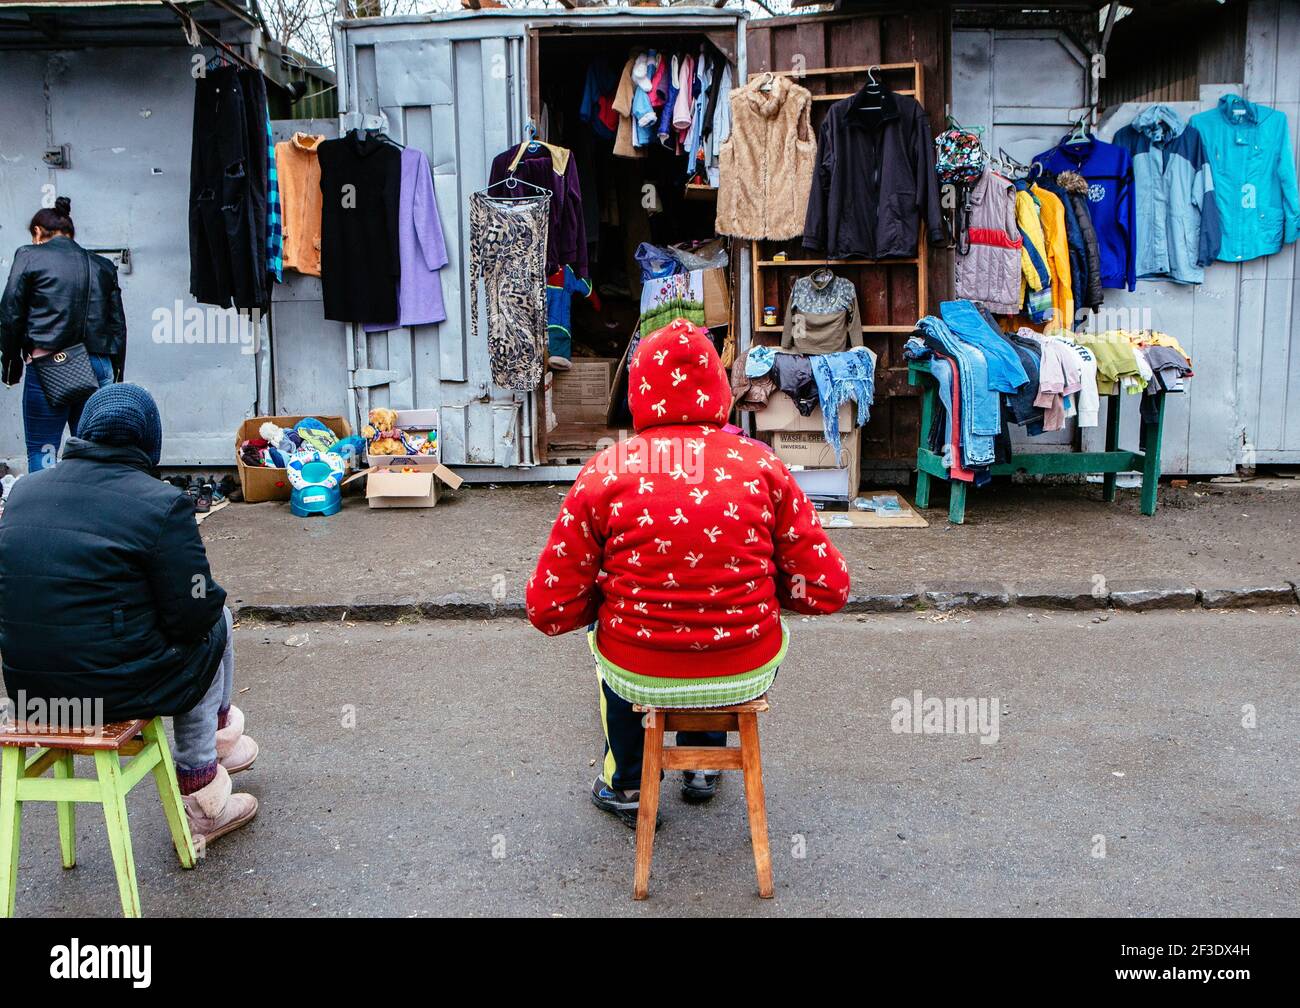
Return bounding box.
[365,147,447,333]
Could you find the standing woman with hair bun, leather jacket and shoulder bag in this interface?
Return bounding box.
[0,196,126,472]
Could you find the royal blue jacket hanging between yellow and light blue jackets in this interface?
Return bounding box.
[1034,135,1138,290]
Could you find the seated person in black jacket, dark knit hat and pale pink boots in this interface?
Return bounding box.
[0,385,257,842]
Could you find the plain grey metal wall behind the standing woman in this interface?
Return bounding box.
[0,47,267,471]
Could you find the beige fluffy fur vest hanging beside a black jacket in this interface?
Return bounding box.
[715,74,816,241]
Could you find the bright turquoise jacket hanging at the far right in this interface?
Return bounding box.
[1190,95,1300,263]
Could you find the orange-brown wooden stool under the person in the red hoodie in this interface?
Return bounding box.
[632,693,772,900]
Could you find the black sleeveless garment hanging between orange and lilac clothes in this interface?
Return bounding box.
[316,130,402,323]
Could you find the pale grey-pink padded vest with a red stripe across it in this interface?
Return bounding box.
[954,168,1023,315]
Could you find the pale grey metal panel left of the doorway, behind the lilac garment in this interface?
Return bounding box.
[342,18,532,467]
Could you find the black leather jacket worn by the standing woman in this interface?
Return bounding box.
[0,235,126,385]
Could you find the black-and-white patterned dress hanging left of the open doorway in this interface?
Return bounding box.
[469,192,551,391]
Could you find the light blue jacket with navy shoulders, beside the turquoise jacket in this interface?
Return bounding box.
[1115,105,1222,284]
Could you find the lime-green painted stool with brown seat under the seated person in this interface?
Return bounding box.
[0,718,195,917]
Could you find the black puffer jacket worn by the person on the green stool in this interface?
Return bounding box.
[0,438,226,721]
